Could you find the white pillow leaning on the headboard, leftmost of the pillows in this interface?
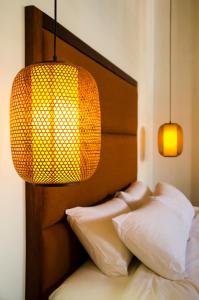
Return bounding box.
[66,198,132,276]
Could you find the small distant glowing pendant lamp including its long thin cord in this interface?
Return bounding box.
[158,0,183,157]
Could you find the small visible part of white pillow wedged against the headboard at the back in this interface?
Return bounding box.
[116,181,152,210]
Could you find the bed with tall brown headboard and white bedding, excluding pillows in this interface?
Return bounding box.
[25,6,199,300]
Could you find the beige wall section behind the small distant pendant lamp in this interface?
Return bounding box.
[153,0,194,197]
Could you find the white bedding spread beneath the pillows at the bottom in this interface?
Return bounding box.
[49,208,199,300]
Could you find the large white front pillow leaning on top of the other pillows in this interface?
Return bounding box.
[113,196,190,280]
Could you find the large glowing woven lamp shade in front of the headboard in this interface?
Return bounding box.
[10,62,101,184]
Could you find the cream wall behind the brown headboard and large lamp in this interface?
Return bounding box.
[0,0,153,300]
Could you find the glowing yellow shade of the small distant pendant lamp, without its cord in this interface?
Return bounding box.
[158,123,183,157]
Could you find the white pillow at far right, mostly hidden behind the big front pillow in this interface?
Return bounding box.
[154,182,195,226]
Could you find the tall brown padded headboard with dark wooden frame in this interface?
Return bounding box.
[25,6,137,300]
